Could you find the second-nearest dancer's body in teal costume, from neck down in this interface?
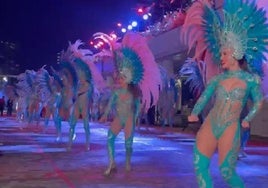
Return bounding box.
[104,88,140,174]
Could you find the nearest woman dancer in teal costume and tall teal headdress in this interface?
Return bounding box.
[188,0,268,188]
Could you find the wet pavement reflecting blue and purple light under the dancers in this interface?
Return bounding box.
[0,117,268,188]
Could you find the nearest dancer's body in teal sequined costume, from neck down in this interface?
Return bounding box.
[192,70,262,188]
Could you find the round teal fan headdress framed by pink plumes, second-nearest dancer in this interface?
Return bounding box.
[115,47,144,84]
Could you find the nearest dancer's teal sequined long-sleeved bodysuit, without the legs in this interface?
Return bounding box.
[192,70,262,139]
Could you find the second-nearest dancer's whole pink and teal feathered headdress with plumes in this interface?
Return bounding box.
[94,32,162,109]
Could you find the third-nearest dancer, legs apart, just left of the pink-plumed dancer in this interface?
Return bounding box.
[68,40,105,150]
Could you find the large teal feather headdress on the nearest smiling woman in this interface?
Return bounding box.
[203,0,268,75]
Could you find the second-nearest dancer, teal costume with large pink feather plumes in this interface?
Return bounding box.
[95,32,162,176]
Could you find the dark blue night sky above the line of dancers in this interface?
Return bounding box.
[0,0,148,71]
